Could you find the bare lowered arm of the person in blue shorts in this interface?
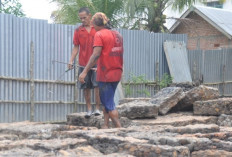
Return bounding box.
[79,47,102,83]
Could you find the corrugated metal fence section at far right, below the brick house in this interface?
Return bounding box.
[188,49,232,96]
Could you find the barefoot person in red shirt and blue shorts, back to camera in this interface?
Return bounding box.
[79,13,123,128]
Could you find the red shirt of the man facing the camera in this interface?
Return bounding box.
[73,26,96,66]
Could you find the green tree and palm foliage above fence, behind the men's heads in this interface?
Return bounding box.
[52,0,214,32]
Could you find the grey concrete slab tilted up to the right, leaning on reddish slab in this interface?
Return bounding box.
[150,87,184,115]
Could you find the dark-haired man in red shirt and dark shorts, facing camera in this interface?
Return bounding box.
[68,7,100,118]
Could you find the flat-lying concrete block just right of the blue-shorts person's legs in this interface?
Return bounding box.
[117,100,158,119]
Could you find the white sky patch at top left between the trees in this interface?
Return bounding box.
[19,0,57,23]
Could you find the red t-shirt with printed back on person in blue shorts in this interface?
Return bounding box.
[93,29,123,82]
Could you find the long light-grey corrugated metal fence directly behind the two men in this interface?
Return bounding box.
[0,14,187,122]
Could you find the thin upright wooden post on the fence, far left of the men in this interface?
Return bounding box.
[30,42,35,122]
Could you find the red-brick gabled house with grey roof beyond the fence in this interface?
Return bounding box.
[169,6,232,50]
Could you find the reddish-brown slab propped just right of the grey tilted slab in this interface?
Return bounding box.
[173,85,219,111]
